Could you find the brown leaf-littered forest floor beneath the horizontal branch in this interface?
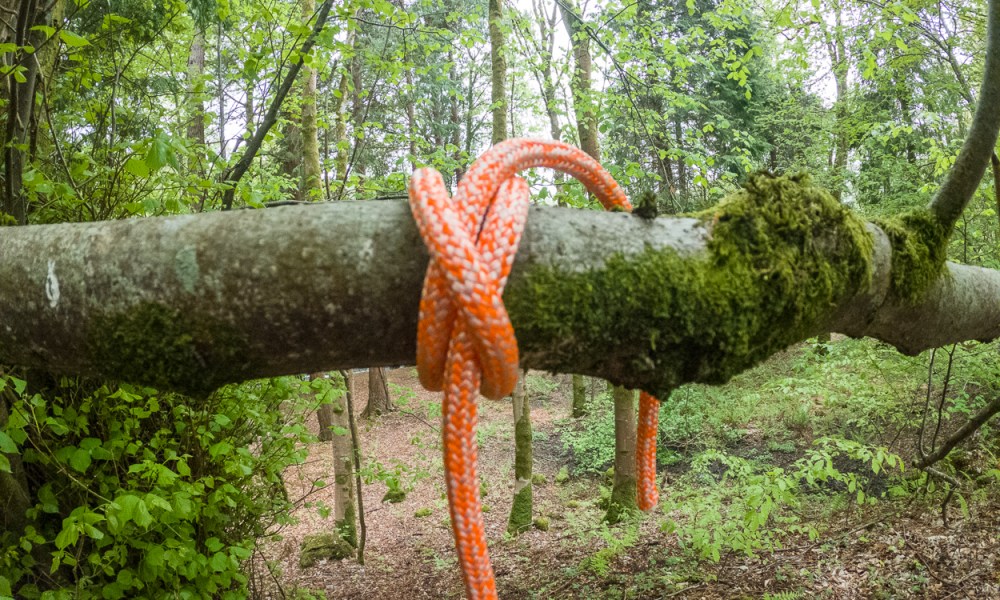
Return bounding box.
[255,346,1000,600]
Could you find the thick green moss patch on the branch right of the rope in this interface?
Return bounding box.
[505,175,872,394]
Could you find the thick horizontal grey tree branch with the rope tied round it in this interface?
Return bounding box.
[0,191,1000,393]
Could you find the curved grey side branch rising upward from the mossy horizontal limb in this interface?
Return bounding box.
[931,0,1000,229]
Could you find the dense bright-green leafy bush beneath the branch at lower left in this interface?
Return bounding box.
[0,376,323,600]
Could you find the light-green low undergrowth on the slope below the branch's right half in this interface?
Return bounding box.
[558,339,1000,589]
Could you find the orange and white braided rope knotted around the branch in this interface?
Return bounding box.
[409,139,659,600]
